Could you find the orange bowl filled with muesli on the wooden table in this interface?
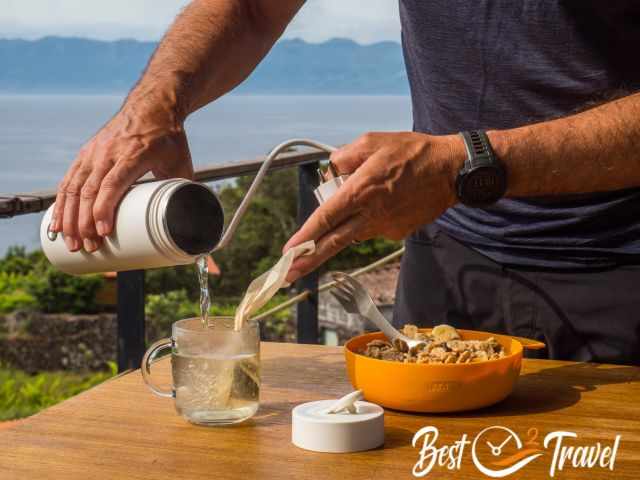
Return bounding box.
[344,326,523,412]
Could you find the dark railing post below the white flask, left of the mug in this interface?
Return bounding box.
[117,270,145,372]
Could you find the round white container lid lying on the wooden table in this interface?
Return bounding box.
[291,392,384,453]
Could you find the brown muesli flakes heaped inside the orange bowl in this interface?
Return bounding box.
[360,325,505,364]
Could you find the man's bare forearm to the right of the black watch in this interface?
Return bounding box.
[489,94,640,197]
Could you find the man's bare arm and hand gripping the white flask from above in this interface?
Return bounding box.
[52,0,304,251]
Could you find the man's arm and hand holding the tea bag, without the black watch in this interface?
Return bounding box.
[284,94,640,281]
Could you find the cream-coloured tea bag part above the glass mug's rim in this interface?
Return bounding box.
[235,240,316,330]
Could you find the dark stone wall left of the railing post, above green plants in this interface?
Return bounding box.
[0,313,117,372]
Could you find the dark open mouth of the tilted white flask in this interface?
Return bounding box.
[165,182,224,255]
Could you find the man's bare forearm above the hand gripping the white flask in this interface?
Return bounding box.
[125,0,304,122]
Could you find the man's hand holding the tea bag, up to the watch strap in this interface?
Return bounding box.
[283,132,466,282]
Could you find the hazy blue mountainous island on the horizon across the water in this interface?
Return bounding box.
[0,37,408,94]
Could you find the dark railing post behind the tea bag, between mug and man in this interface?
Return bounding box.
[296,162,320,343]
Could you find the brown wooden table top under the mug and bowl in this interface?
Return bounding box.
[0,343,640,480]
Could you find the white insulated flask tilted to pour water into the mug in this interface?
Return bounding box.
[40,179,224,275]
